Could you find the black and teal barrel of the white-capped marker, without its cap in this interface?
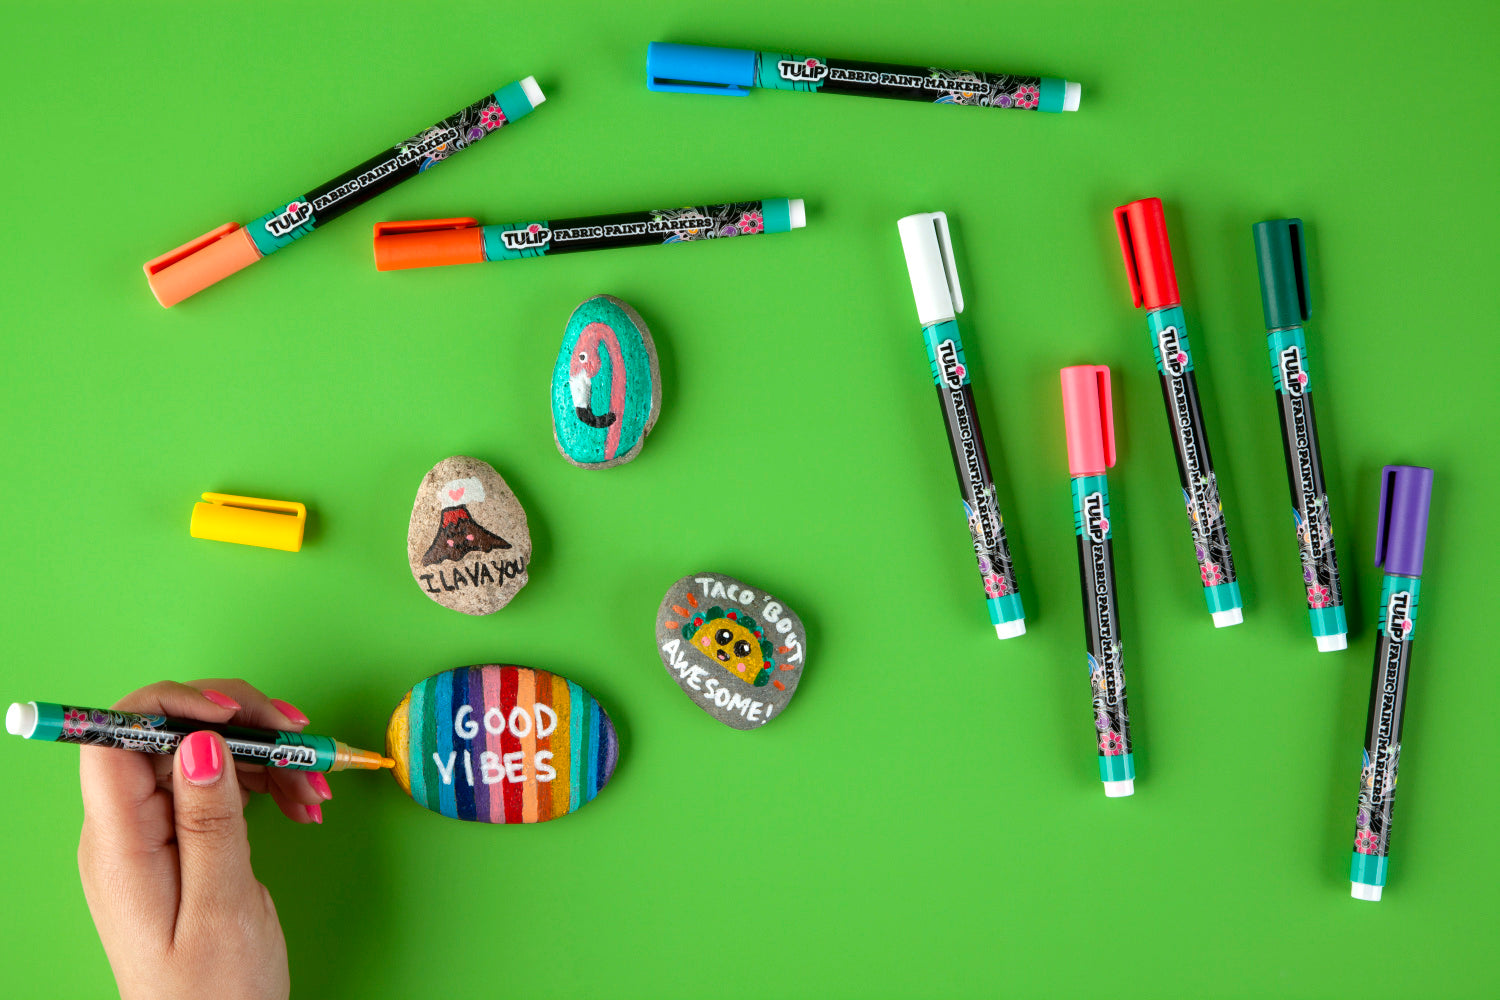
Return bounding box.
[923,319,1026,639]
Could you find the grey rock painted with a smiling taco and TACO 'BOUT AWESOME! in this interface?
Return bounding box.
[657,573,807,729]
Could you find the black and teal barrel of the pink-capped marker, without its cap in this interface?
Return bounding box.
[1073,475,1136,798]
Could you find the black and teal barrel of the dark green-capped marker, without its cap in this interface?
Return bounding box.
[1266,327,1349,652]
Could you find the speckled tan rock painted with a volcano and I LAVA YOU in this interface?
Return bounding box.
[407,456,531,615]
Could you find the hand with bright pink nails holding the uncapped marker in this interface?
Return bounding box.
[78,681,332,1000]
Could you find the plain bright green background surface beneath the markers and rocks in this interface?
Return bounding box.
[0,0,1500,997]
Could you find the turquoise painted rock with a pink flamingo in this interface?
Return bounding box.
[552,295,662,469]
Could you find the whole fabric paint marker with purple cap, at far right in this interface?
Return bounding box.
[1349,465,1433,901]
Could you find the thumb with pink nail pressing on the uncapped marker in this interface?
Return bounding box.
[173,732,257,927]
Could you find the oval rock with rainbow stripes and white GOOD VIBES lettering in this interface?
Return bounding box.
[386,663,620,823]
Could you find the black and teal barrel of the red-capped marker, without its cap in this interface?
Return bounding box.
[1146,306,1244,627]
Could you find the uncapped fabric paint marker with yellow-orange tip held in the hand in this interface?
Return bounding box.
[5,702,396,771]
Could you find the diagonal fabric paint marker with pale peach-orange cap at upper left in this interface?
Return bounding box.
[146,76,546,306]
